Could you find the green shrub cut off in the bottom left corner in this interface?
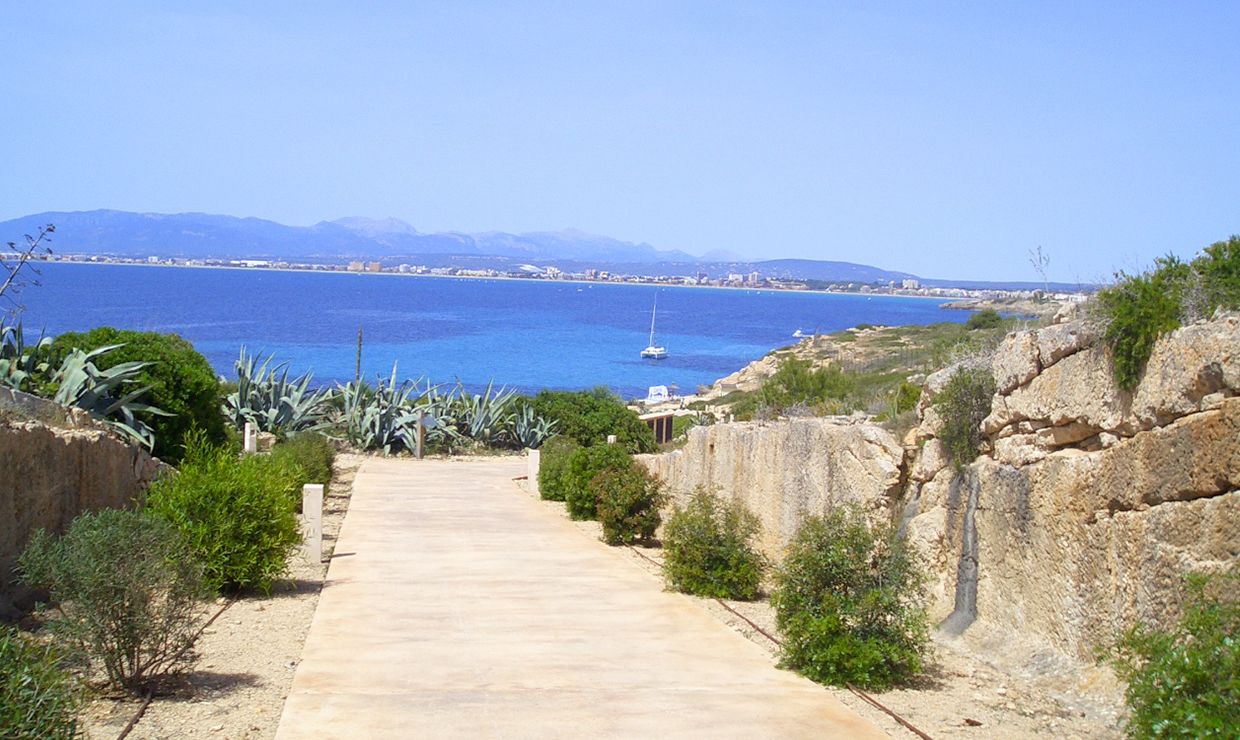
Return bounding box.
[0,625,78,740]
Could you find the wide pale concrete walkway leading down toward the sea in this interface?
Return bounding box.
[277,457,885,740]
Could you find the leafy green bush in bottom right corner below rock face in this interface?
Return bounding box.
[1112,565,1240,738]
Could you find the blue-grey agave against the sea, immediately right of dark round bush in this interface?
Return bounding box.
[223,347,331,434]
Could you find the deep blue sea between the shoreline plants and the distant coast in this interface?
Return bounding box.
[19,263,968,397]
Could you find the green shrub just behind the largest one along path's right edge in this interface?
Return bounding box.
[663,490,765,601]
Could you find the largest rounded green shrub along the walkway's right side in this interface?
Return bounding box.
[771,507,929,689]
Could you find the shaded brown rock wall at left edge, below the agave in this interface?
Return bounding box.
[0,391,161,619]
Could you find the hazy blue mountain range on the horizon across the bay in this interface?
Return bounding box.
[0,211,915,283]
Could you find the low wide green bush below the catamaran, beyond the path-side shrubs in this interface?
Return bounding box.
[527,388,657,454]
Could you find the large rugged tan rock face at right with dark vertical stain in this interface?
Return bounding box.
[905,315,1240,658]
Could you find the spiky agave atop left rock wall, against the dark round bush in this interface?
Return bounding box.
[52,345,170,450]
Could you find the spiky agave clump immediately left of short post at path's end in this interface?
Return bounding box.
[340,364,418,455]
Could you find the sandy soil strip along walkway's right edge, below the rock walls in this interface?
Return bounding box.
[522,481,1123,740]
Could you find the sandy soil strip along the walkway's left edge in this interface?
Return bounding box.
[83,454,365,740]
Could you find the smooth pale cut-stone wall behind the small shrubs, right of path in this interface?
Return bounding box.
[637,419,904,559]
